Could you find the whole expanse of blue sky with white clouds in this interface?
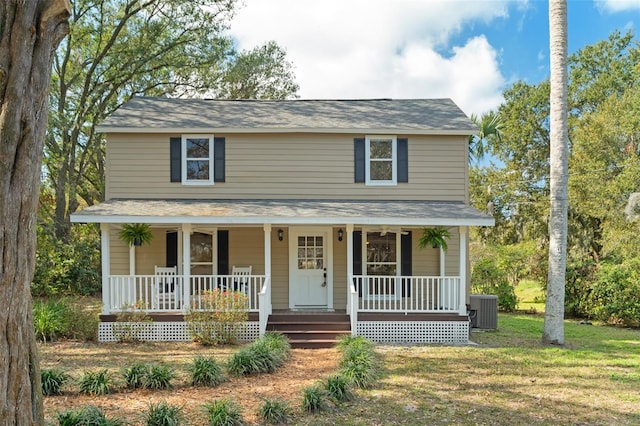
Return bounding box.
[230,0,640,115]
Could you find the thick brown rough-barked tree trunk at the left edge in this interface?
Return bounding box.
[0,0,70,426]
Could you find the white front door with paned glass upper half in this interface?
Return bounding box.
[289,228,333,309]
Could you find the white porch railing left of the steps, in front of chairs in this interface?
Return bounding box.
[108,275,266,312]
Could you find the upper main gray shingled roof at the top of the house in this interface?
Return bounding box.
[98,97,478,135]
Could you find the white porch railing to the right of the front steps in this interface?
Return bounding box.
[350,275,461,313]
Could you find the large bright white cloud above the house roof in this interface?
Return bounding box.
[231,0,526,114]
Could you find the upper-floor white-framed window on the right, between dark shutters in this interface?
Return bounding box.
[365,136,397,185]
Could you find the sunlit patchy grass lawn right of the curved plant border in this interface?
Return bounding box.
[301,314,640,425]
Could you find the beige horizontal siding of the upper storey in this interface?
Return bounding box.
[106,134,467,201]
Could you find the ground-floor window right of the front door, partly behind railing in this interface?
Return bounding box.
[365,232,400,298]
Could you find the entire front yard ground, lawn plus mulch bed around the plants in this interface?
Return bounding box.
[41,314,640,425]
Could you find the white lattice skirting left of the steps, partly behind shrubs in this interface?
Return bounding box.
[98,321,260,342]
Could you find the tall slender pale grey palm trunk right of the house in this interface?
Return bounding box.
[542,0,569,345]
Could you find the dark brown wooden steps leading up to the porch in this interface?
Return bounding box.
[267,313,351,349]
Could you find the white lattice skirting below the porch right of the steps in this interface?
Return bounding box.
[357,321,469,344]
